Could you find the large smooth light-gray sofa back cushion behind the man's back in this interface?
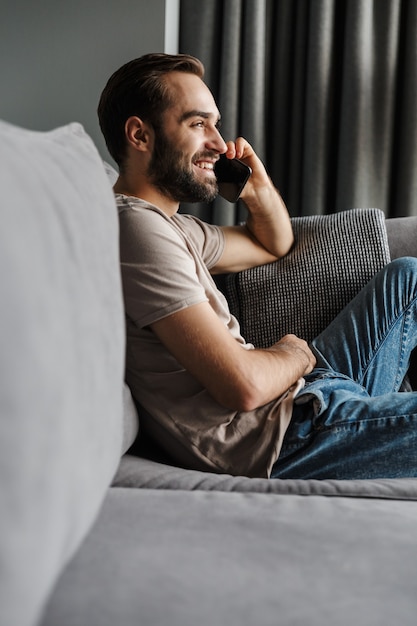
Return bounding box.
[0,122,124,626]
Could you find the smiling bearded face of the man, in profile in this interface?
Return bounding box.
[148,72,226,202]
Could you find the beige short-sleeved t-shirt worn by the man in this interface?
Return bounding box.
[116,195,302,477]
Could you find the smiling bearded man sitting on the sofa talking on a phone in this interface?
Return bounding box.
[98,54,417,478]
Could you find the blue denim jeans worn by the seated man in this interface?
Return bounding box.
[271,257,417,479]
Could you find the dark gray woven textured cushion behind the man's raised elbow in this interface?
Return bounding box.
[225,209,390,348]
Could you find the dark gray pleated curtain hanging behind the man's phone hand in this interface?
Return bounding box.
[180,0,417,224]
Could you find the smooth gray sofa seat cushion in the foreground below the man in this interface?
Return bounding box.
[40,489,417,626]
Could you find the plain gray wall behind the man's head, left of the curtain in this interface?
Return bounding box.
[0,0,179,161]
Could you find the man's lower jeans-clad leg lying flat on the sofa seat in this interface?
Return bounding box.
[271,378,417,480]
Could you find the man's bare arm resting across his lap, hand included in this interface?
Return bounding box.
[151,302,316,411]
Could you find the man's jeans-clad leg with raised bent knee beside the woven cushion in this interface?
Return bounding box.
[311,257,417,396]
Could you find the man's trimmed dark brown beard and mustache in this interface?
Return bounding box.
[148,129,219,202]
